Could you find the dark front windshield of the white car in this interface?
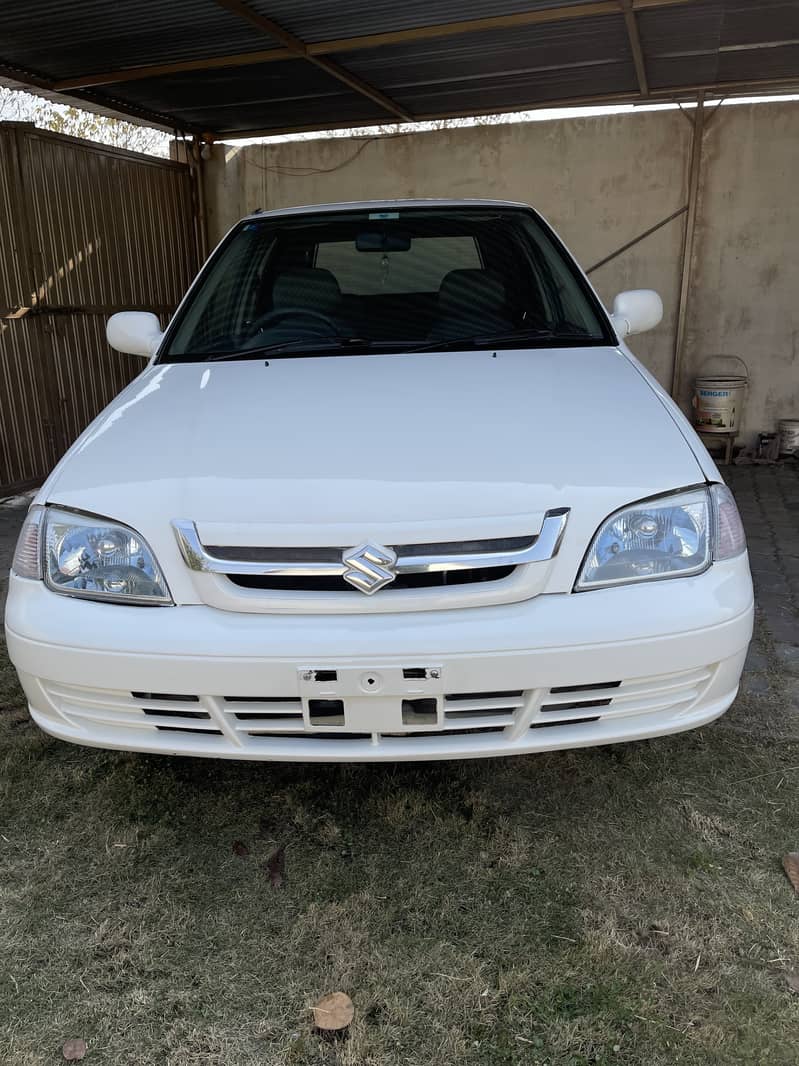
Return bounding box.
[158,207,613,362]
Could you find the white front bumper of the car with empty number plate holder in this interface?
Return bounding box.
[6,556,752,762]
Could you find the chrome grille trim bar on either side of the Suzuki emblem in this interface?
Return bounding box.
[172,507,569,578]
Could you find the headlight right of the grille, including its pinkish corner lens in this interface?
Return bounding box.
[574,485,746,592]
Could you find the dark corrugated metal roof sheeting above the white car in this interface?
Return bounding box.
[0,0,799,133]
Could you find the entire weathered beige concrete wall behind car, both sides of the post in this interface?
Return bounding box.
[206,103,799,438]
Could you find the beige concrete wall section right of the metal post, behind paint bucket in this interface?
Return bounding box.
[680,103,799,434]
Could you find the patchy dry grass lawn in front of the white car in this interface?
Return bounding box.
[0,626,799,1066]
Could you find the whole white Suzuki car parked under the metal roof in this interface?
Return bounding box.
[6,200,752,762]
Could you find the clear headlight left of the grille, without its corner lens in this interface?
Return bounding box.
[38,507,172,605]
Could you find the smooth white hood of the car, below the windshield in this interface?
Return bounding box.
[44,348,704,545]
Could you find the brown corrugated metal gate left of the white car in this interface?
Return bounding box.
[0,123,200,495]
